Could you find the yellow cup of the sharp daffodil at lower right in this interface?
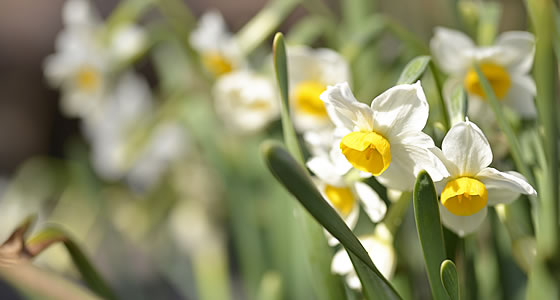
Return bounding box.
[441,177,488,216]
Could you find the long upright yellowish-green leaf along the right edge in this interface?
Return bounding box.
[527,0,560,259]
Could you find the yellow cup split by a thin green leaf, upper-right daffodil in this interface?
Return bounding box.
[464,63,511,99]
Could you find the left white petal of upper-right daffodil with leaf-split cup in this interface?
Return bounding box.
[430,27,474,74]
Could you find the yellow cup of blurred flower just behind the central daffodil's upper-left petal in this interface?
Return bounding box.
[294,81,327,117]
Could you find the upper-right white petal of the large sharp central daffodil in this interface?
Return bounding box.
[371,81,429,139]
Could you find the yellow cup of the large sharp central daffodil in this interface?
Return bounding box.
[340,131,391,176]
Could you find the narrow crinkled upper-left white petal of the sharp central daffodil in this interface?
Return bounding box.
[320,82,373,131]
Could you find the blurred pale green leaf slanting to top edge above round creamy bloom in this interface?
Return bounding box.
[236,0,300,55]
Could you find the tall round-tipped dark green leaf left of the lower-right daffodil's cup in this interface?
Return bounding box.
[413,171,448,300]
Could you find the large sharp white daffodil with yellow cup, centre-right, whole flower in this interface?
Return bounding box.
[321,82,448,191]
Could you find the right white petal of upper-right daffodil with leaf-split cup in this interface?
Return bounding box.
[496,31,535,74]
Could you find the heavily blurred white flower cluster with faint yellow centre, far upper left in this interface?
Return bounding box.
[44,0,146,117]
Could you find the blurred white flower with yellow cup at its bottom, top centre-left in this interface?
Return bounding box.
[190,10,244,76]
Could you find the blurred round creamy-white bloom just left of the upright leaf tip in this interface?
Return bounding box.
[213,70,280,132]
